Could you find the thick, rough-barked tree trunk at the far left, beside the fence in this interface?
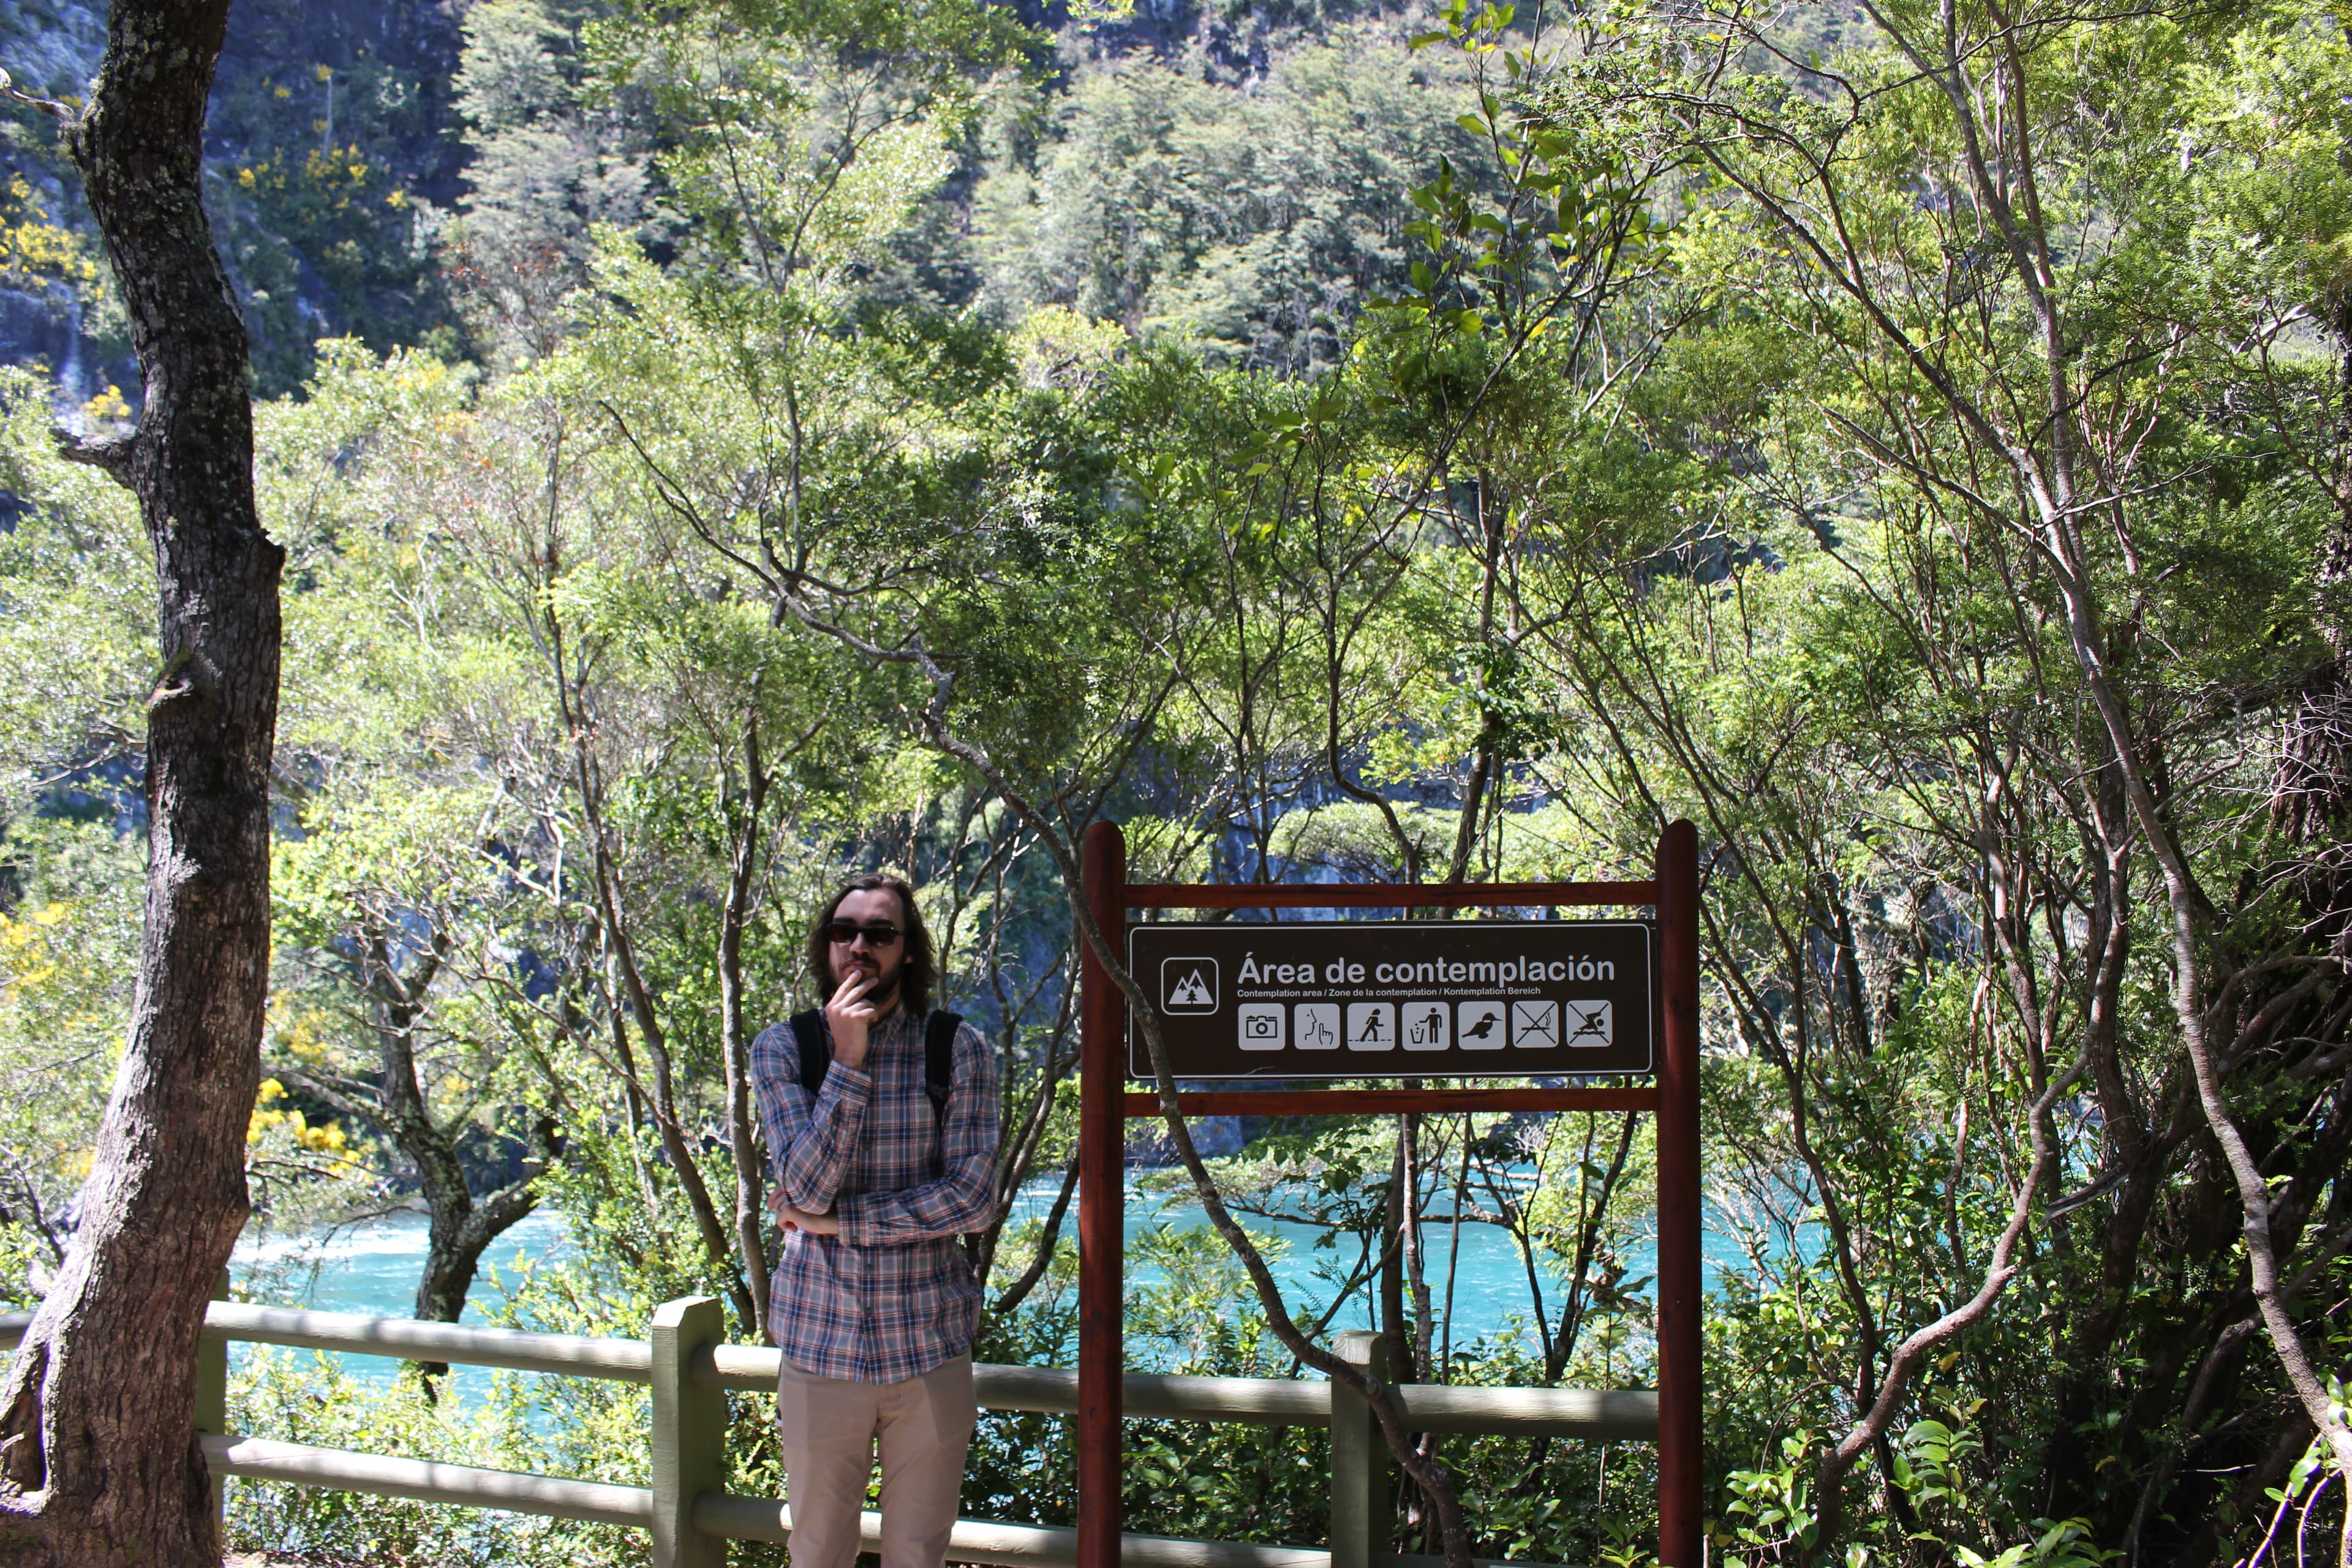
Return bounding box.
[0,0,285,1568]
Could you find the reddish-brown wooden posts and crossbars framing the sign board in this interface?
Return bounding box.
[1077,823,1700,1568]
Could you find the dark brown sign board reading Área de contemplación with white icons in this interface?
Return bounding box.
[1126,919,1656,1079]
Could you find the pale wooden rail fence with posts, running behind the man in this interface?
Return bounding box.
[0,1295,1658,1568]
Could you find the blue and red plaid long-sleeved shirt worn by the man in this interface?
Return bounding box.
[750,1009,997,1382]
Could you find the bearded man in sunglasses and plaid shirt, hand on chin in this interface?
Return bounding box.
[750,875,997,1568]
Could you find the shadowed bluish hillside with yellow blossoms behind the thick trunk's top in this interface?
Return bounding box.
[0,0,463,404]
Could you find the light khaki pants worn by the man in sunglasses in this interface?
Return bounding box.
[776,1354,978,1568]
